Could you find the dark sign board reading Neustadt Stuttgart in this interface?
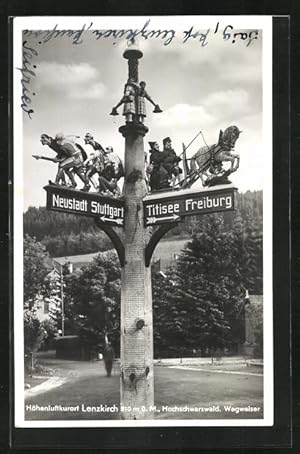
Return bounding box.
[44,185,124,226]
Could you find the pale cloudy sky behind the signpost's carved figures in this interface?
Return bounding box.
[15,19,268,210]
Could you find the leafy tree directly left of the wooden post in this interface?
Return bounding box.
[65,252,121,352]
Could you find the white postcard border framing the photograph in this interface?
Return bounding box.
[13,16,274,428]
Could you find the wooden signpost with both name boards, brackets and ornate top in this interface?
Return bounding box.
[45,40,236,419]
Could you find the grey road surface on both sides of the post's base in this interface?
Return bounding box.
[25,359,263,420]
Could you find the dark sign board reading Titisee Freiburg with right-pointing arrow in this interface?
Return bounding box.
[144,185,236,226]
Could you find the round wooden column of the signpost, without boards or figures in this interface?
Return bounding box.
[120,48,154,419]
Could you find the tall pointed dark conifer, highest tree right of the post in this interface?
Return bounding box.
[176,216,231,353]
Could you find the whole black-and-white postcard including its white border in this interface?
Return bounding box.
[13,15,274,428]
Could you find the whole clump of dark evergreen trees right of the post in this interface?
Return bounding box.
[153,214,262,356]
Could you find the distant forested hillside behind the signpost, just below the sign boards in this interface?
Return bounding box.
[24,191,263,257]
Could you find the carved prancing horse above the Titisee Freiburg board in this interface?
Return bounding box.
[188,126,242,185]
